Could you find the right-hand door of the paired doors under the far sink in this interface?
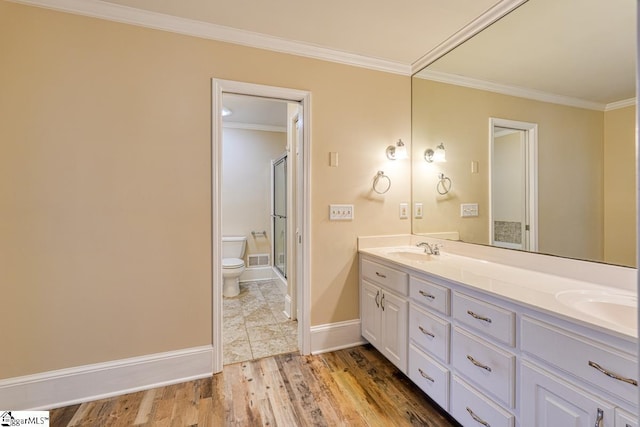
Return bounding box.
[380,290,409,374]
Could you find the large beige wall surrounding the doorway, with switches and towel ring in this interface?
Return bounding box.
[0,1,410,378]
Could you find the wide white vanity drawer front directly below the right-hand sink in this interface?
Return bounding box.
[520,316,638,405]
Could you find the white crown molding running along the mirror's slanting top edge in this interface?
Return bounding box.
[411,0,528,74]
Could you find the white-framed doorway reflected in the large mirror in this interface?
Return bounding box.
[489,118,538,251]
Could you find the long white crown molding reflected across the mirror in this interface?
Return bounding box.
[415,70,612,111]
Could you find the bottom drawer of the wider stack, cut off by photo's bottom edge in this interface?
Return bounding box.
[451,375,515,427]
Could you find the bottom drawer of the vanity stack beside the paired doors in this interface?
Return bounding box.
[409,344,449,411]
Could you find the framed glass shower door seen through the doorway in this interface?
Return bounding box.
[271,154,287,279]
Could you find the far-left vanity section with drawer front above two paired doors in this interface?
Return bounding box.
[360,259,408,374]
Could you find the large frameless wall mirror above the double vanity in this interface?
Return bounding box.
[412,0,636,266]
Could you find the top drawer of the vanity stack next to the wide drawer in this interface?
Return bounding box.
[453,292,515,347]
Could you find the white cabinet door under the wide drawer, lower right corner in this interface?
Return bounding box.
[520,361,615,427]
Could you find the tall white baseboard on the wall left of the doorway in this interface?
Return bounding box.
[0,346,213,410]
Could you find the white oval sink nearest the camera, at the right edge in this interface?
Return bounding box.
[556,290,638,328]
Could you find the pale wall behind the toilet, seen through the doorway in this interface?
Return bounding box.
[221,128,287,255]
